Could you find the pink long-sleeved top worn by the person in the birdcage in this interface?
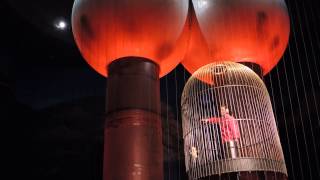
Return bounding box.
[202,114,240,143]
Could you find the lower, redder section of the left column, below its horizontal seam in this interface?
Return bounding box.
[104,110,163,180]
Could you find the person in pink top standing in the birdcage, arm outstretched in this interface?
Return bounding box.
[201,106,241,158]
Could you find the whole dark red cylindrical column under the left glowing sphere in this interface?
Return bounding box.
[103,57,163,180]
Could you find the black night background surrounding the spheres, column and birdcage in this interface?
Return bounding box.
[0,0,320,180]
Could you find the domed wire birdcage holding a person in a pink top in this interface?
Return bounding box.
[181,62,287,179]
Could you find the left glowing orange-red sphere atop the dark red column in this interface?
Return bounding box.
[72,0,189,76]
